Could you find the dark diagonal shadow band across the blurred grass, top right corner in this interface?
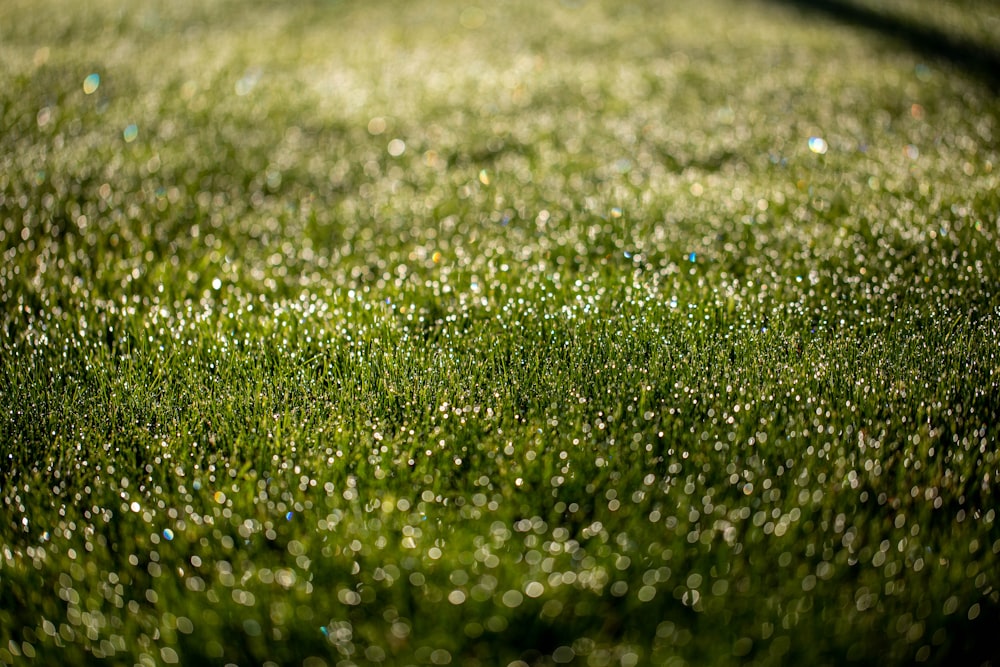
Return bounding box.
[771,0,1000,94]
